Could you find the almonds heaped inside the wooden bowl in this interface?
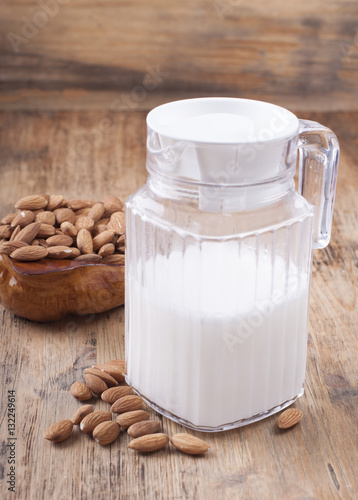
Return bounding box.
[0,194,125,265]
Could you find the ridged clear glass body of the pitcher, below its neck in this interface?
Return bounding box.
[126,197,313,430]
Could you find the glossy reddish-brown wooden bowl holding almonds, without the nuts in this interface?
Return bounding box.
[0,254,124,322]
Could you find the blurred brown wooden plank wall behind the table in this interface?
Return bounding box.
[0,0,358,110]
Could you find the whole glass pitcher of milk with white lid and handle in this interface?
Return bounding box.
[126,98,339,431]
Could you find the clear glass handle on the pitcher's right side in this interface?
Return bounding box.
[298,120,339,248]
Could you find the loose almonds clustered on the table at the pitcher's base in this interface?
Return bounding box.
[45,359,210,455]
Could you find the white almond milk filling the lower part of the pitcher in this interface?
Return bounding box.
[127,242,308,430]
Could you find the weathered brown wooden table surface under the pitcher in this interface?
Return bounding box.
[0,112,358,500]
